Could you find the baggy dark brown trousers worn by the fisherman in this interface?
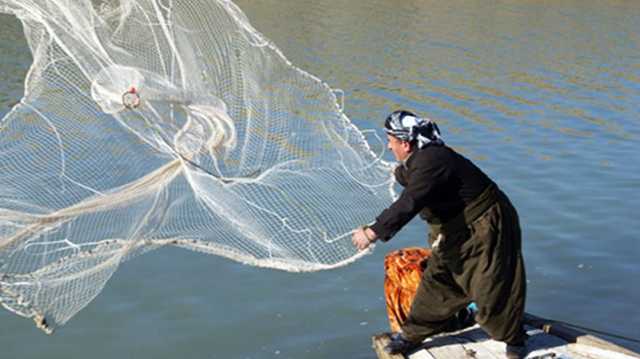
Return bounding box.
[402,192,526,344]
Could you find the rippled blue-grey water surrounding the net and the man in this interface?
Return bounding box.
[0,0,640,359]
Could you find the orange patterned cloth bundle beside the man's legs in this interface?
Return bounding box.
[384,247,431,332]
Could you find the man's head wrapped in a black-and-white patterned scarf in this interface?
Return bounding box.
[384,110,444,161]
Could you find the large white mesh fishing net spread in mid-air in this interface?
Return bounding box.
[0,0,393,332]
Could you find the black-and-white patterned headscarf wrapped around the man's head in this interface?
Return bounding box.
[384,110,444,149]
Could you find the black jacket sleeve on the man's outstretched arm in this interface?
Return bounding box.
[371,154,448,242]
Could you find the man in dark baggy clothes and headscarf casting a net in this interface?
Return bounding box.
[352,110,526,358]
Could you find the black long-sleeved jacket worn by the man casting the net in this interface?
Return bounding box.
[371,145,493,241]
